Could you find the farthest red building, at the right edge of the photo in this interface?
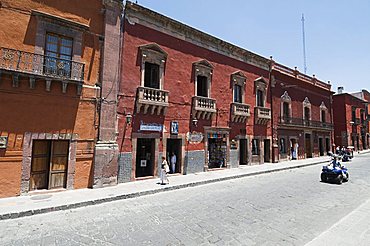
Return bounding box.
[333,87,370,150]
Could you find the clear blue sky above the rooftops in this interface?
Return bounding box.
[132,0,370,92]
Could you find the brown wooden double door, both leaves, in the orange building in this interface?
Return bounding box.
[29,140,69,191]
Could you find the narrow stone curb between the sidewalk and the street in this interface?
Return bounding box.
[0,161,327,221]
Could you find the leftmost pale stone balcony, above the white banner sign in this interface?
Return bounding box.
[136,87,168,115]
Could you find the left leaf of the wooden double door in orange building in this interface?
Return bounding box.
[30,140,51,191]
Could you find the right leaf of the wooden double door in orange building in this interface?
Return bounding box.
[49,141,69,189]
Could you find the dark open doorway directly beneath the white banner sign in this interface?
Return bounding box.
[135,138,155,178]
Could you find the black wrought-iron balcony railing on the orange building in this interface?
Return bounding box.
[0,47,85,82]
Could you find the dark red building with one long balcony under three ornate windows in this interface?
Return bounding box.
[272,64,333,160]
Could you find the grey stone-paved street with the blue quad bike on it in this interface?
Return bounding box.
[0,154,370,245]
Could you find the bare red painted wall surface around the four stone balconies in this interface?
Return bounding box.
[118,21,271,152]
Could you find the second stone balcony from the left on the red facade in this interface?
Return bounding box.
[192,96,216,119]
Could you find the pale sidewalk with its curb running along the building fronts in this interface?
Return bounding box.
[0,156,329,220]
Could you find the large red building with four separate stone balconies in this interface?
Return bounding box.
[118,2,272,182]
